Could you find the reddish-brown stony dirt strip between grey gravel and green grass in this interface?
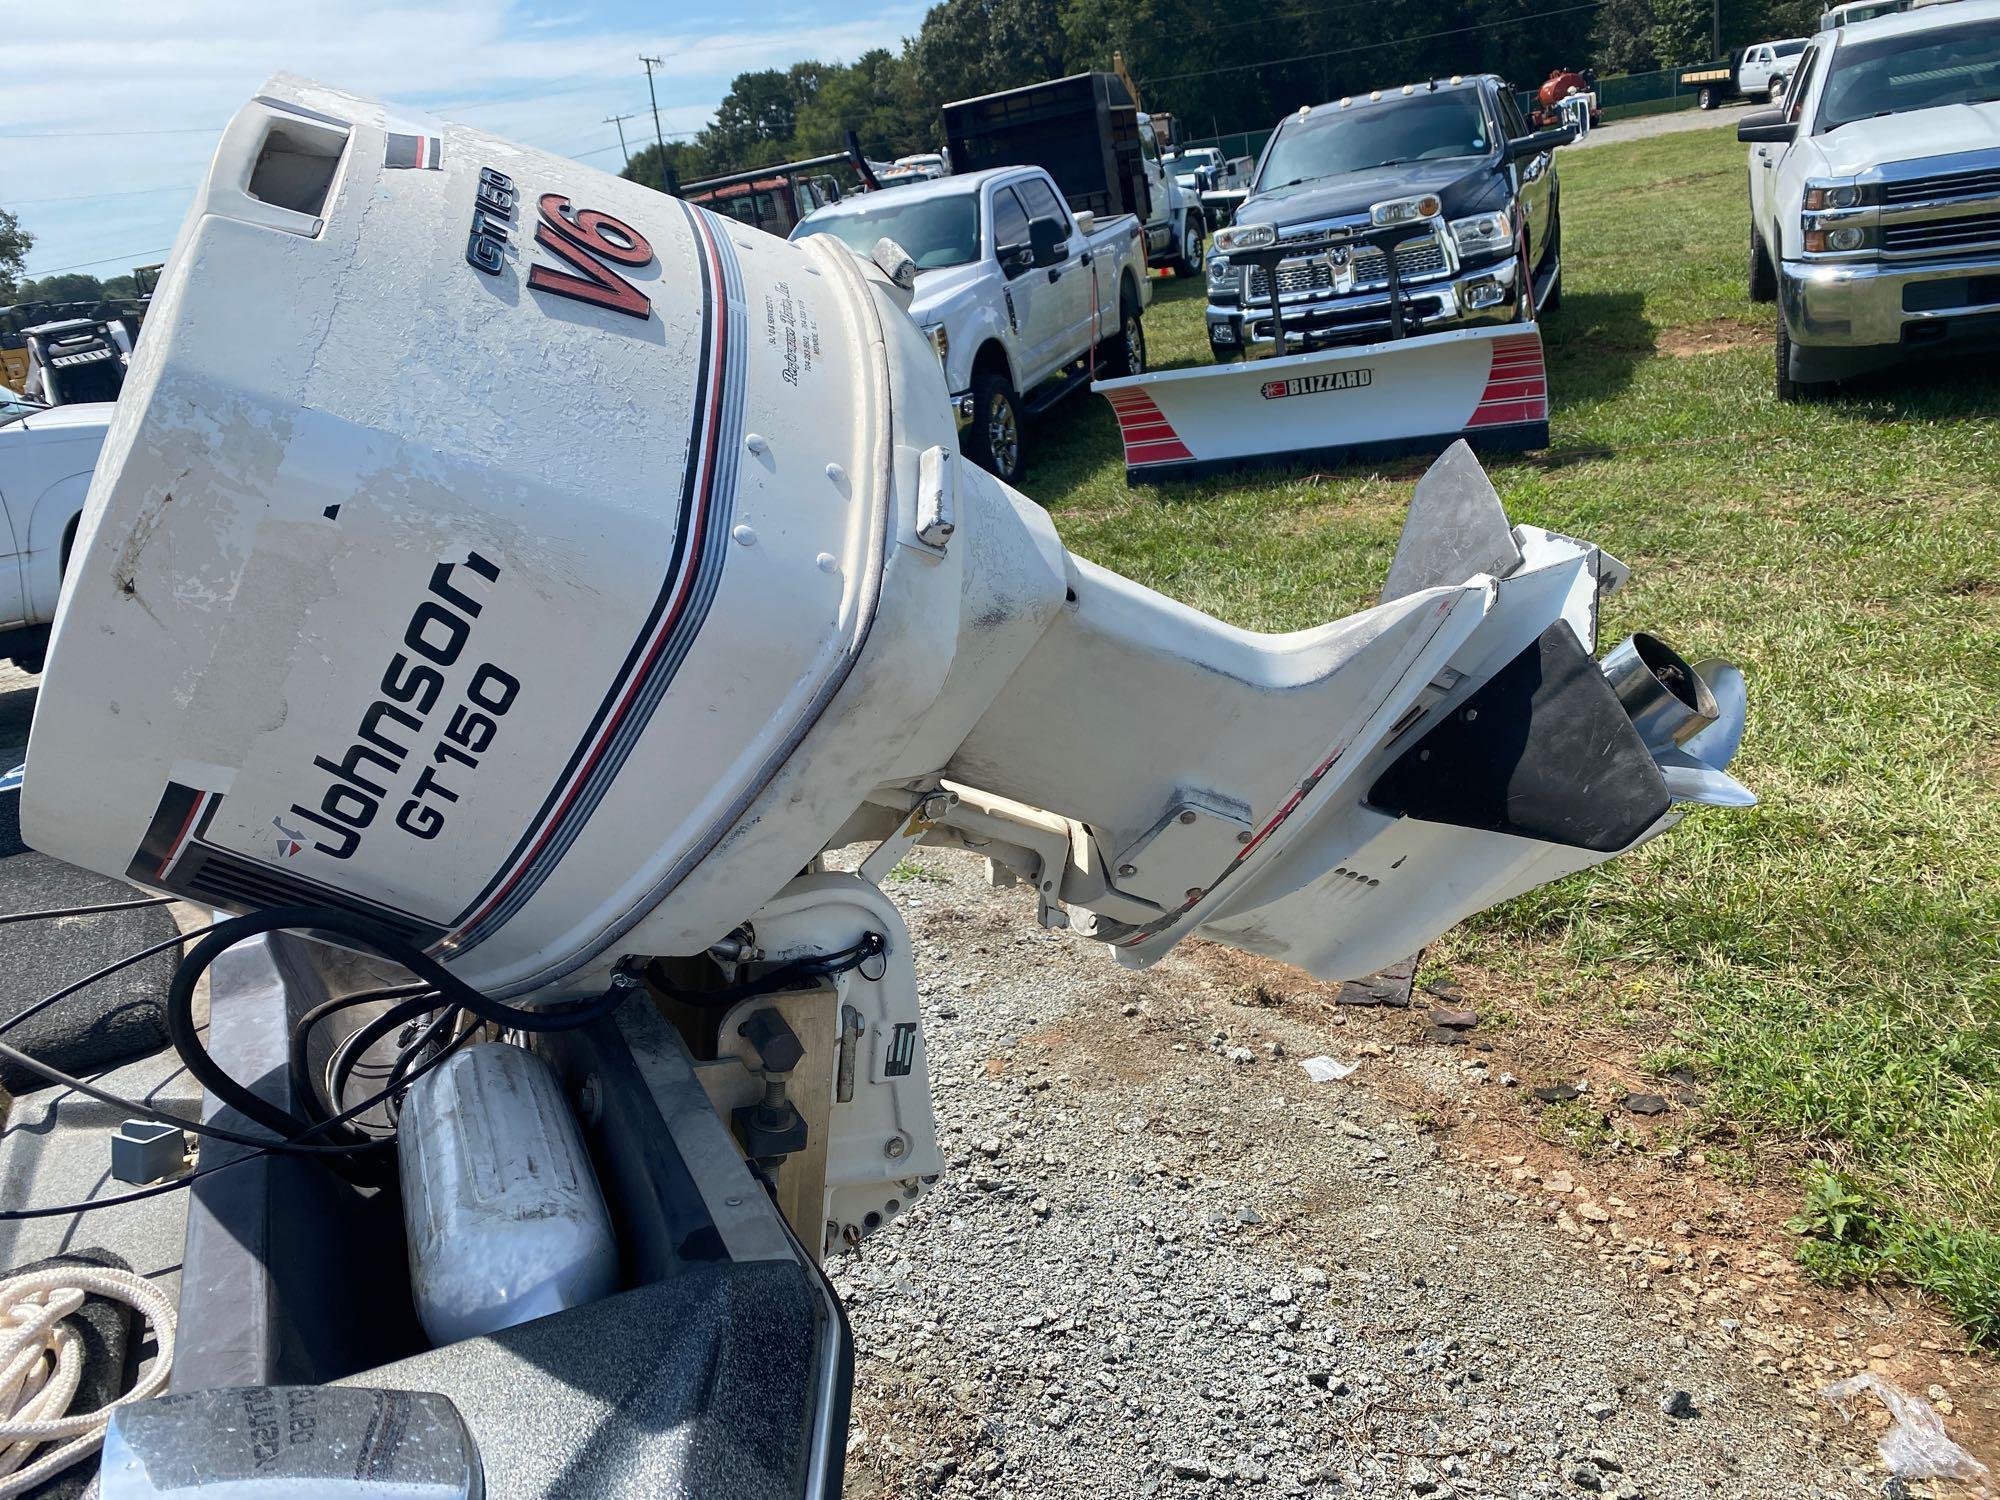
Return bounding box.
[1178,942,2000,1494]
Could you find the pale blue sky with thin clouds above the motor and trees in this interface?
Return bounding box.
[0,0,926,276]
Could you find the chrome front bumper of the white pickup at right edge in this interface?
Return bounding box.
[1778,256,2000,348]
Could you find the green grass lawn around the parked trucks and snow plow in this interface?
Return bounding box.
[1026,130,2000,1342]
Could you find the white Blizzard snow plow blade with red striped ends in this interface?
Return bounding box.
[1094,324,1548,482]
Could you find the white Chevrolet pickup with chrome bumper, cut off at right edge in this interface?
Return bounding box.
[1736,0,2000,400]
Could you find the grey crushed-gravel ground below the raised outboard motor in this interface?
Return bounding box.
[830,854,1894,1500]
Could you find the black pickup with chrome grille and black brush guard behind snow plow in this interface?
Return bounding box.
[1208,74,1572,360]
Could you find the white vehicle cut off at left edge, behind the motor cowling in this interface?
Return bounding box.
[0,386,112,672]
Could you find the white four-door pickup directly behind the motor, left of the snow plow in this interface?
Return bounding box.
[790,166,1152,484]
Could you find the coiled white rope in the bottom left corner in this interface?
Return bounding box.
[0,1266,174,1500]
